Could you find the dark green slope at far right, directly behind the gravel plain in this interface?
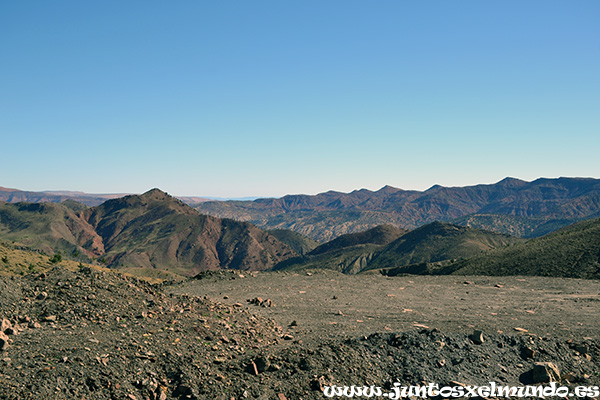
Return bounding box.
[454,219,600,279]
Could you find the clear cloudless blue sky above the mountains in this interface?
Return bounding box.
[0,0,600,197]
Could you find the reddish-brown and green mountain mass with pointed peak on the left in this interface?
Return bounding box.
[0,189,297,275]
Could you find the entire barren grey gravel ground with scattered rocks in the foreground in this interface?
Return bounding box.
[0,266,600,400]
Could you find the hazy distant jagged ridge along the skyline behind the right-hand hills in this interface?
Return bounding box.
[195,178,600,243]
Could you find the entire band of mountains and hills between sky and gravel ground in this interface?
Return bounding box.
[0,178,600,278]
